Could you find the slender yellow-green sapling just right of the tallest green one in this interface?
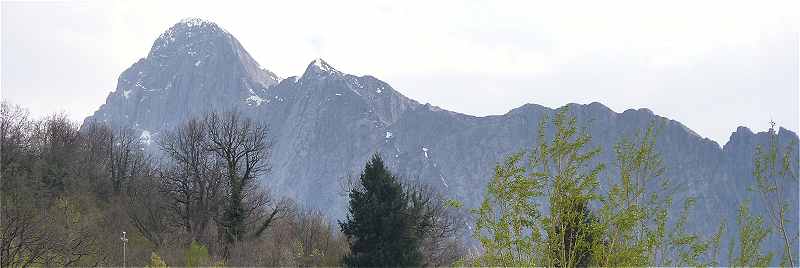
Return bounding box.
[594,124,668,266]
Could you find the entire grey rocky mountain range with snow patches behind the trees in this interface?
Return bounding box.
[85,19,798,260]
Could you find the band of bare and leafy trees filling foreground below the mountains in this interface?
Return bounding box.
[0,103,798,266]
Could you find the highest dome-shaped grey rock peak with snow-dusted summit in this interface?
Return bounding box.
[84,19,279,143]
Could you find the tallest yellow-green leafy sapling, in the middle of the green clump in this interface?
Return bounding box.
[531,108,605,267]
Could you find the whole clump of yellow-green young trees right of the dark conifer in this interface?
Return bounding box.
[462,108,736,267]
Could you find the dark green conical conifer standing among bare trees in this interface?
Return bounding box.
[339,154,422,267]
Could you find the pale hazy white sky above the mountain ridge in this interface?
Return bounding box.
[0,1,800,144]
